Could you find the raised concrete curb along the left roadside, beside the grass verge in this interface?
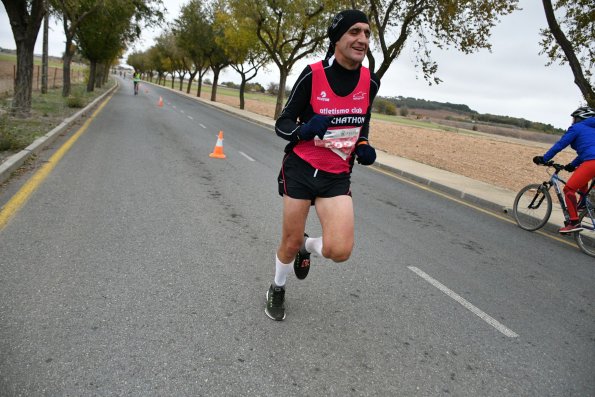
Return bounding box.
[0,81,120,183]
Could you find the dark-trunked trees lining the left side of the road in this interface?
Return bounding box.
[2,0,163,117]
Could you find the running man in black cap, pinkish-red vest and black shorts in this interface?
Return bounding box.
[265,10,380,321]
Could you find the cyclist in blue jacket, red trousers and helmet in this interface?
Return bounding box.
[533,106,595,234]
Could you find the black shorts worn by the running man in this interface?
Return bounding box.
[277,152,351,204]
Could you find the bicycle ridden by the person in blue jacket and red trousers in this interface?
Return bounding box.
[512,161,595,257]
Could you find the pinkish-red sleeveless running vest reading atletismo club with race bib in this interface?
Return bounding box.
[293,61,370,174]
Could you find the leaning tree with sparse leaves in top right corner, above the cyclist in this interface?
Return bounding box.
[540,0,595,107]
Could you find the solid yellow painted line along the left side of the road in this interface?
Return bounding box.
[0,94,113,231]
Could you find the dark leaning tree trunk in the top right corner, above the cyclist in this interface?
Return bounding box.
[543,0,595,107]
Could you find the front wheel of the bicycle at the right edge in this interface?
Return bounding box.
[512,184,552,231]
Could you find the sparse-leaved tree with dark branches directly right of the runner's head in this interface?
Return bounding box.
[352,0,518,84]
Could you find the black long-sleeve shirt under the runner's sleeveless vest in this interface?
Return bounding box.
[275,58,380,143]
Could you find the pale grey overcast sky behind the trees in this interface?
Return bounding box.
[0,0,582,128]
